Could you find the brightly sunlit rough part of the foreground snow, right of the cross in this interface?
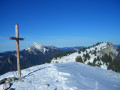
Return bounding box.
[9,64,73,90]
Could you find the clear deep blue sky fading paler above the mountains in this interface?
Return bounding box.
[0,0,120,51]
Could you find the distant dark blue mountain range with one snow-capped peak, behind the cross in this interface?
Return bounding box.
[0,42,83,75]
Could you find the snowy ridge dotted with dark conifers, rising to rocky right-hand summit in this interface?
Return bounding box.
[51,42,119,70]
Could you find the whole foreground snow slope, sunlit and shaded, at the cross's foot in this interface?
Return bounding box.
[0,62,120,90]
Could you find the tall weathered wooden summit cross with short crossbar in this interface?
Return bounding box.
[9,24,24,79]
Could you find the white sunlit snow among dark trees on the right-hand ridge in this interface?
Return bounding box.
[51,42,118,70]
